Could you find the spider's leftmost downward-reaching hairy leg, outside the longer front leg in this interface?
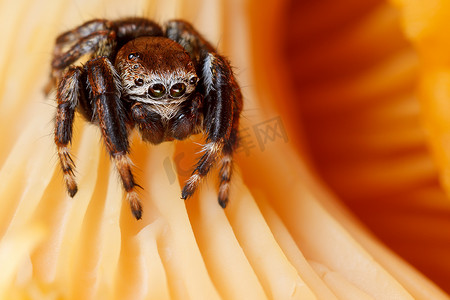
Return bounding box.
[55,67,82,197]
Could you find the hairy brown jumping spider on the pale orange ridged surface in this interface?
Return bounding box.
[51,18,242,220]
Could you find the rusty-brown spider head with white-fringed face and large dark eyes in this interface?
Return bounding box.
[115,37,198,104]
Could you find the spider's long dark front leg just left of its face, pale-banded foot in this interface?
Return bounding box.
[85,57,142,219]
